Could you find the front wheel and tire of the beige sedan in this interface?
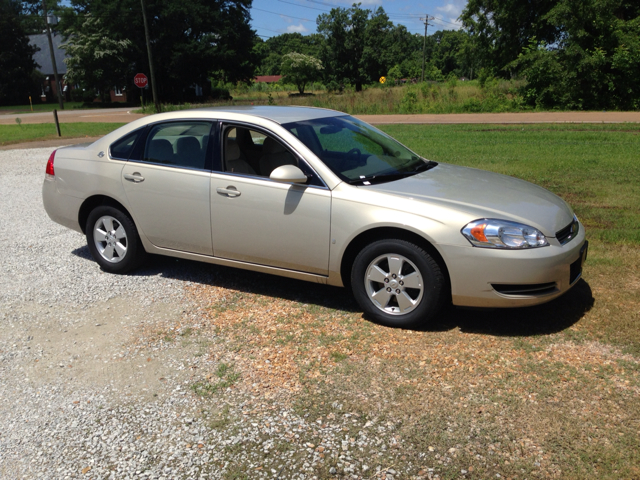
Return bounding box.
[351,239,445,328]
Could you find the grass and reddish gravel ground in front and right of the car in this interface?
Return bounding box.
[158,125,640,479]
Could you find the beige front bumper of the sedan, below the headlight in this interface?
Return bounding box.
[440,228,588,307]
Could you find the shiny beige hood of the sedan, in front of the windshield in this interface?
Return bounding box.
[367,163,573,237]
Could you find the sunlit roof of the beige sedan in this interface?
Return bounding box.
[182,105,347,124]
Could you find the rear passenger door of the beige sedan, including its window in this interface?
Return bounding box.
[117,120,213,255]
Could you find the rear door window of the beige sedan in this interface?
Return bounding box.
[144,121,211,169]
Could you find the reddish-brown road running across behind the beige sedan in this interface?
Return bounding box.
[0,108,640,125]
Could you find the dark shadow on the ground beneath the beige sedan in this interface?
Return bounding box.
[72,246,595,337]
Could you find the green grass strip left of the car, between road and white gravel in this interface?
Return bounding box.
[0,123,125,145]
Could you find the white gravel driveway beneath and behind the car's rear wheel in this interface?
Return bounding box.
[0,148,410,479]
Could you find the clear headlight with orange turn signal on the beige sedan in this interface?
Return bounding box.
[462,218,549,249]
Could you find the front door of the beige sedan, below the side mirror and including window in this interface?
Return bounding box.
[211,124,331,275]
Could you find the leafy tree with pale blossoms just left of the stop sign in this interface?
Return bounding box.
[64,14,131,102]
